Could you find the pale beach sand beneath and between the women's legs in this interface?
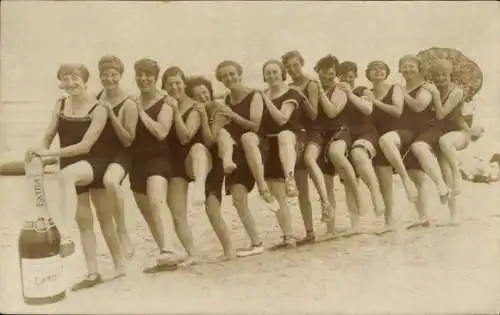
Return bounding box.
[0,175,500,314]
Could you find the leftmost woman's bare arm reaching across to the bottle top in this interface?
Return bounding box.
[44,105,108,157]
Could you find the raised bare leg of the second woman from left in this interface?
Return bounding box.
[103,163,134,259]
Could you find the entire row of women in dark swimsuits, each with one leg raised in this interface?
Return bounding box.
[28,51,479,290]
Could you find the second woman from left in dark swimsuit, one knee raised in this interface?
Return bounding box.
[98,55,138,259]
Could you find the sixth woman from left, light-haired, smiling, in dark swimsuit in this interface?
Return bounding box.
[215,60,275,256]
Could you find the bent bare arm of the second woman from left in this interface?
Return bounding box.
[108,100,139,147]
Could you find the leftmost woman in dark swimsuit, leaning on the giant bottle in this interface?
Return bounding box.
[27,64,124,291]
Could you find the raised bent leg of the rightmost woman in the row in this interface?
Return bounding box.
[439,131,468,196]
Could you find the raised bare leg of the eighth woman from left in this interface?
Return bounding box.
[304,142,333,222]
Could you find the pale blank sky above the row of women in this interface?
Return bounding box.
[0,1,500,111]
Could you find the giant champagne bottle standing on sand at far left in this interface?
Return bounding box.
[19,157,66,305]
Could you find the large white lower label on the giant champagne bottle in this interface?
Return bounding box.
[21,255,66,298]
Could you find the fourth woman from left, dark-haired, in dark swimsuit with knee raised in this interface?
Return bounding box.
[162,67,212,266]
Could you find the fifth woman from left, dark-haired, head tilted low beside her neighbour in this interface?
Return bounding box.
[186,77,236,260]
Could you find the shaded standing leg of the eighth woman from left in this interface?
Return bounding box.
[295,169,316,245]
